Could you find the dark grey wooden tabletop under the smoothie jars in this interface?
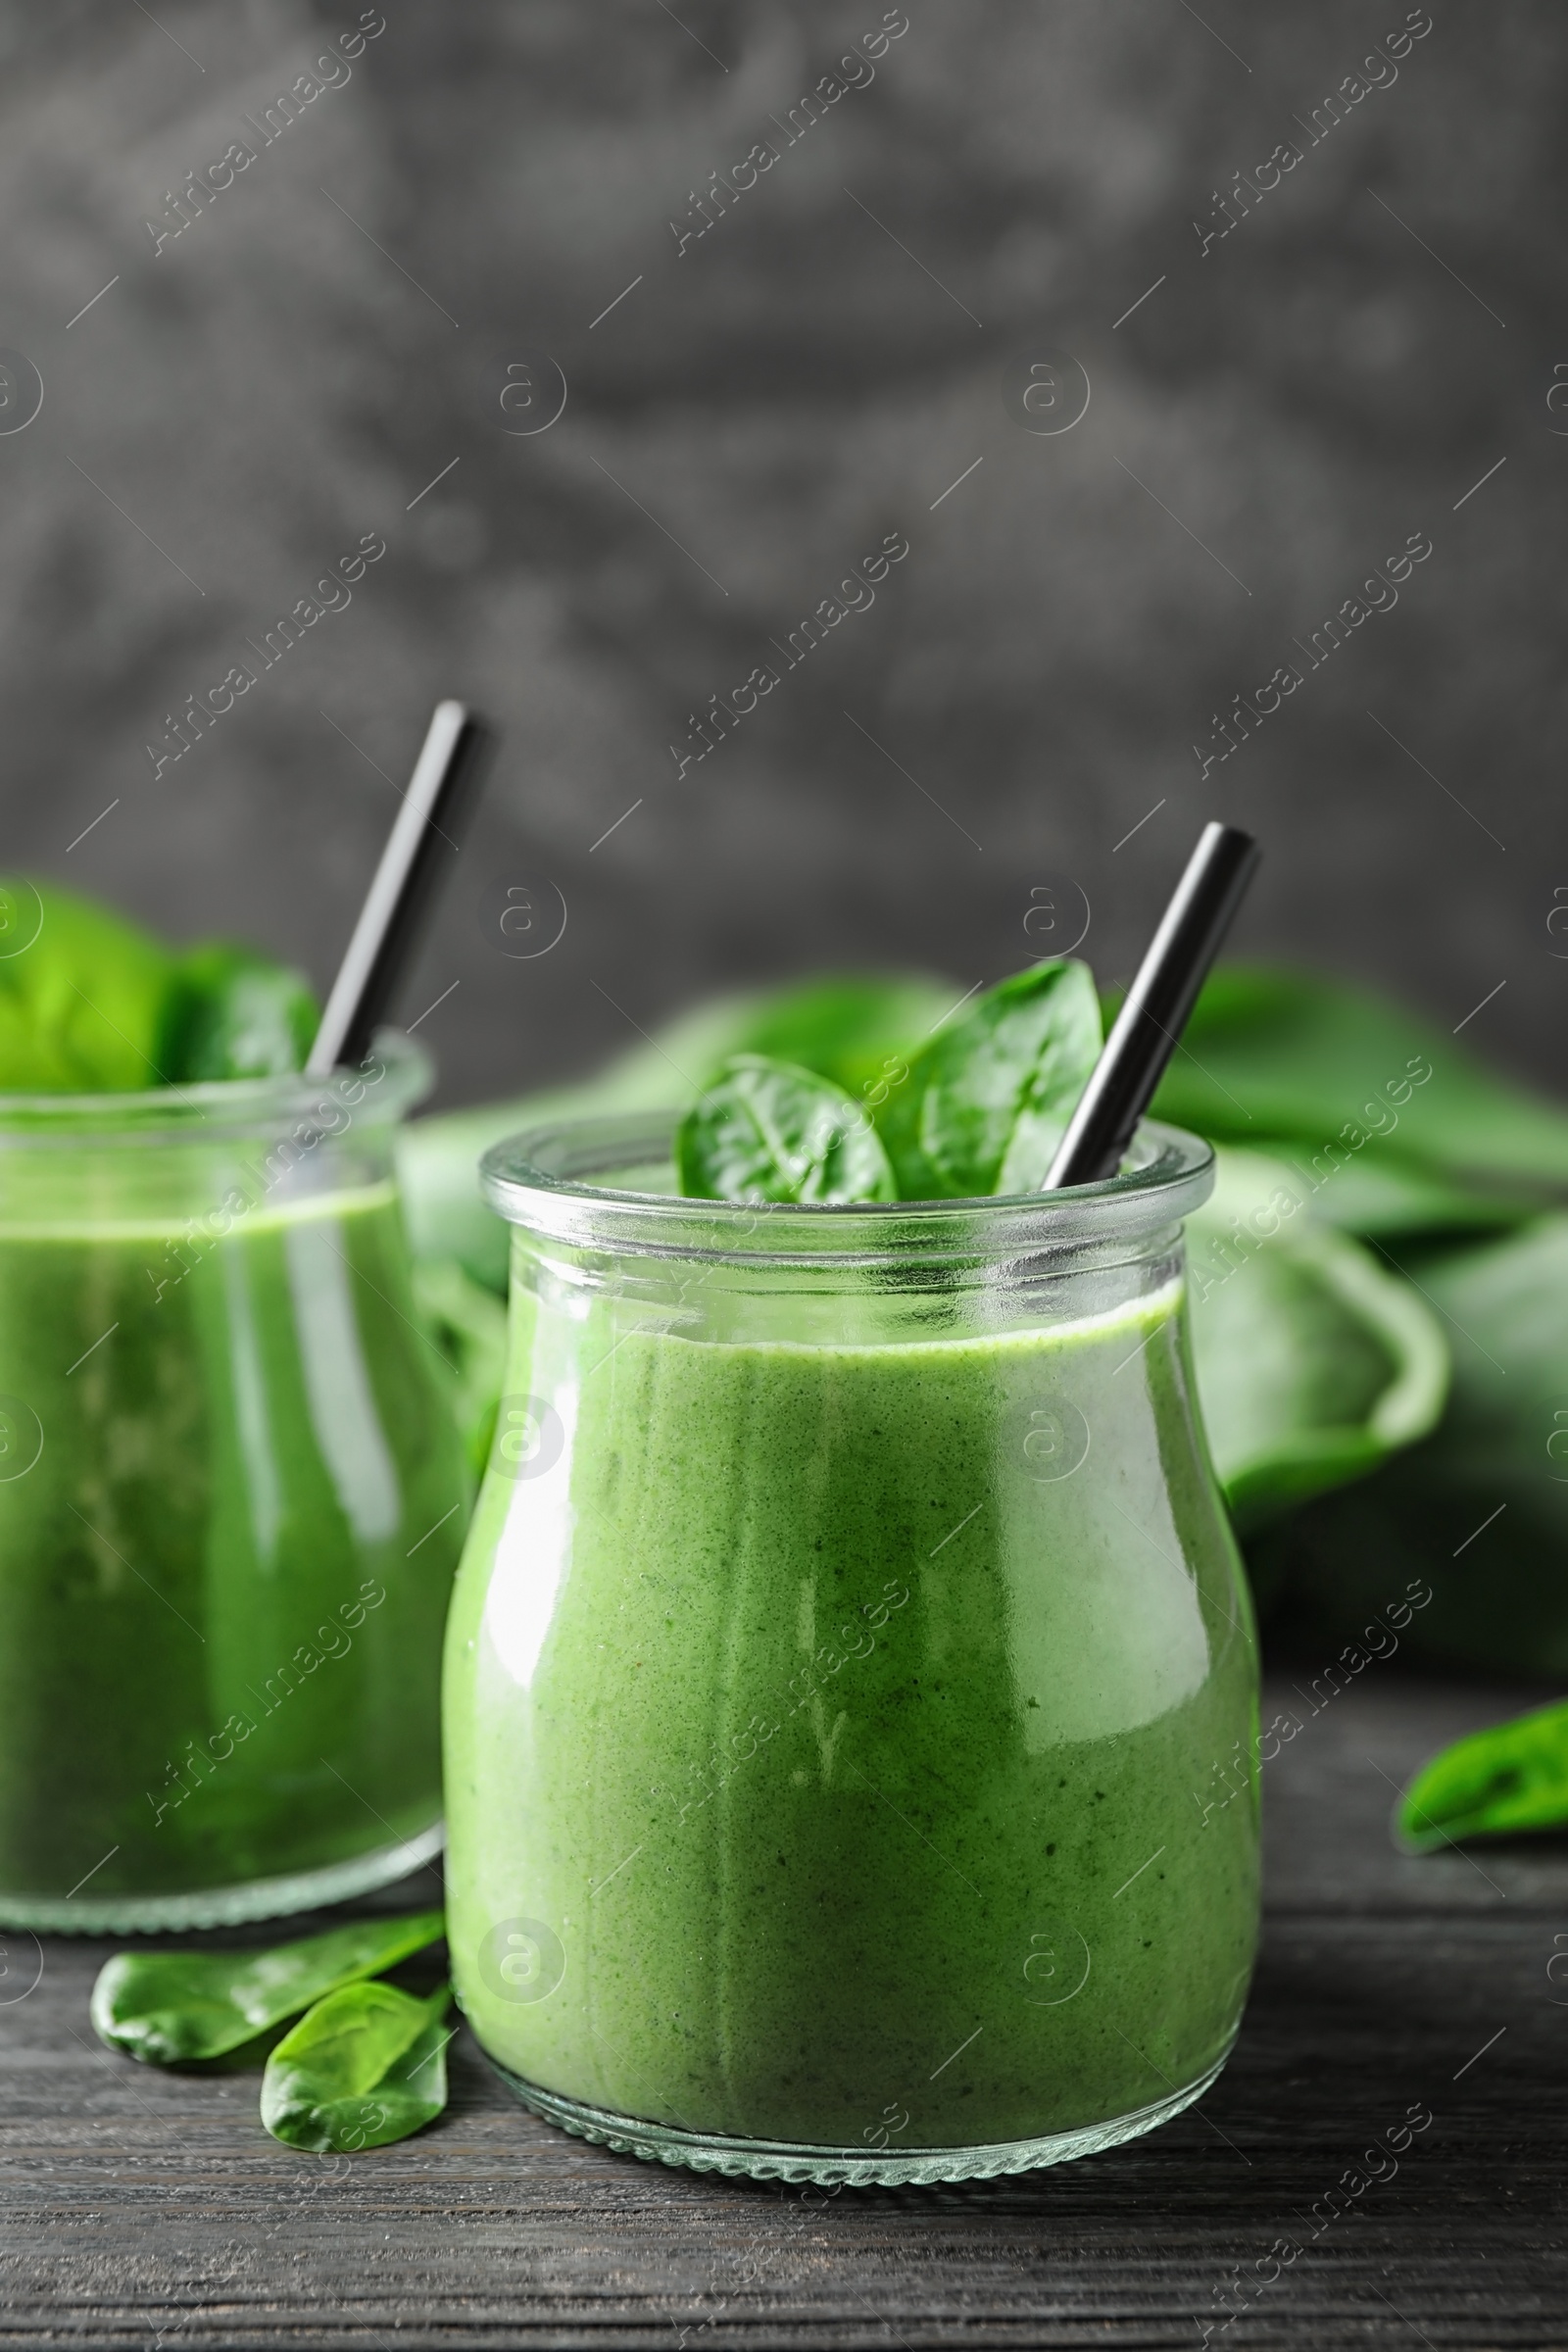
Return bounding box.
[0,1663,1568,2352]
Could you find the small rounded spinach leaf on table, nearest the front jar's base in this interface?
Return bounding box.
[261,1983,452,2150]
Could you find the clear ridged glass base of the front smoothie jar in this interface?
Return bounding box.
[487,2034,1234,2189]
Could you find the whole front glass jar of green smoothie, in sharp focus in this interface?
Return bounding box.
[444,1117,1257,2182]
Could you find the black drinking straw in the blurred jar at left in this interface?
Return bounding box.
[306,704,489,1077]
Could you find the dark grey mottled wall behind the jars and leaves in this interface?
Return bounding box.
[0,0,1568,1101]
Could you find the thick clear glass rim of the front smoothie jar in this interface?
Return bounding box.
[479,1110,1213,1263]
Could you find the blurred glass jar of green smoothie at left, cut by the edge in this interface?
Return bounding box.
[0,1037,466,1931]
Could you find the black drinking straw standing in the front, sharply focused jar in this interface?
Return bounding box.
[1044,825,1260,1193]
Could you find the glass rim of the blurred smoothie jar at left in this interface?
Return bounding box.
[0,1030,435,1151]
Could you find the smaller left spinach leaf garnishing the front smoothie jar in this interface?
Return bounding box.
[674,1054,898,1201]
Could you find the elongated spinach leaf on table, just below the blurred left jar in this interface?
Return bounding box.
[92,1910,444,2065]
